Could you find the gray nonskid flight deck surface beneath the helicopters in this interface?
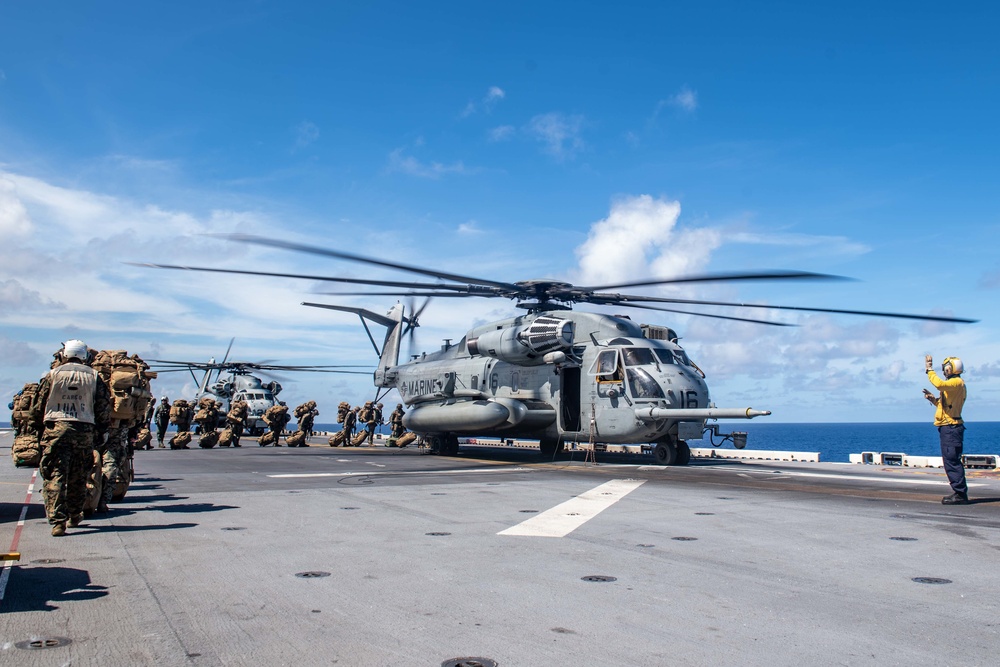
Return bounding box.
[0,435,1000,667]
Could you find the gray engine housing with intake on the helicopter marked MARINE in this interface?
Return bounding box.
[468,315,573,366]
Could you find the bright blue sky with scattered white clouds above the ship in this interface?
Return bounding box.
[0,2,1000,421]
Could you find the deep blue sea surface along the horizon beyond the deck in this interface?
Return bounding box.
[0,421,1000,463]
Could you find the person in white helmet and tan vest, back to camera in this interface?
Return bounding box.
[30,340,111,537]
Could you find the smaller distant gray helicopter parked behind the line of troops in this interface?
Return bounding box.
[149,339,369,436]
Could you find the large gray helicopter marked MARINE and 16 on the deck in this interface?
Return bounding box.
[140,234,976,465]
